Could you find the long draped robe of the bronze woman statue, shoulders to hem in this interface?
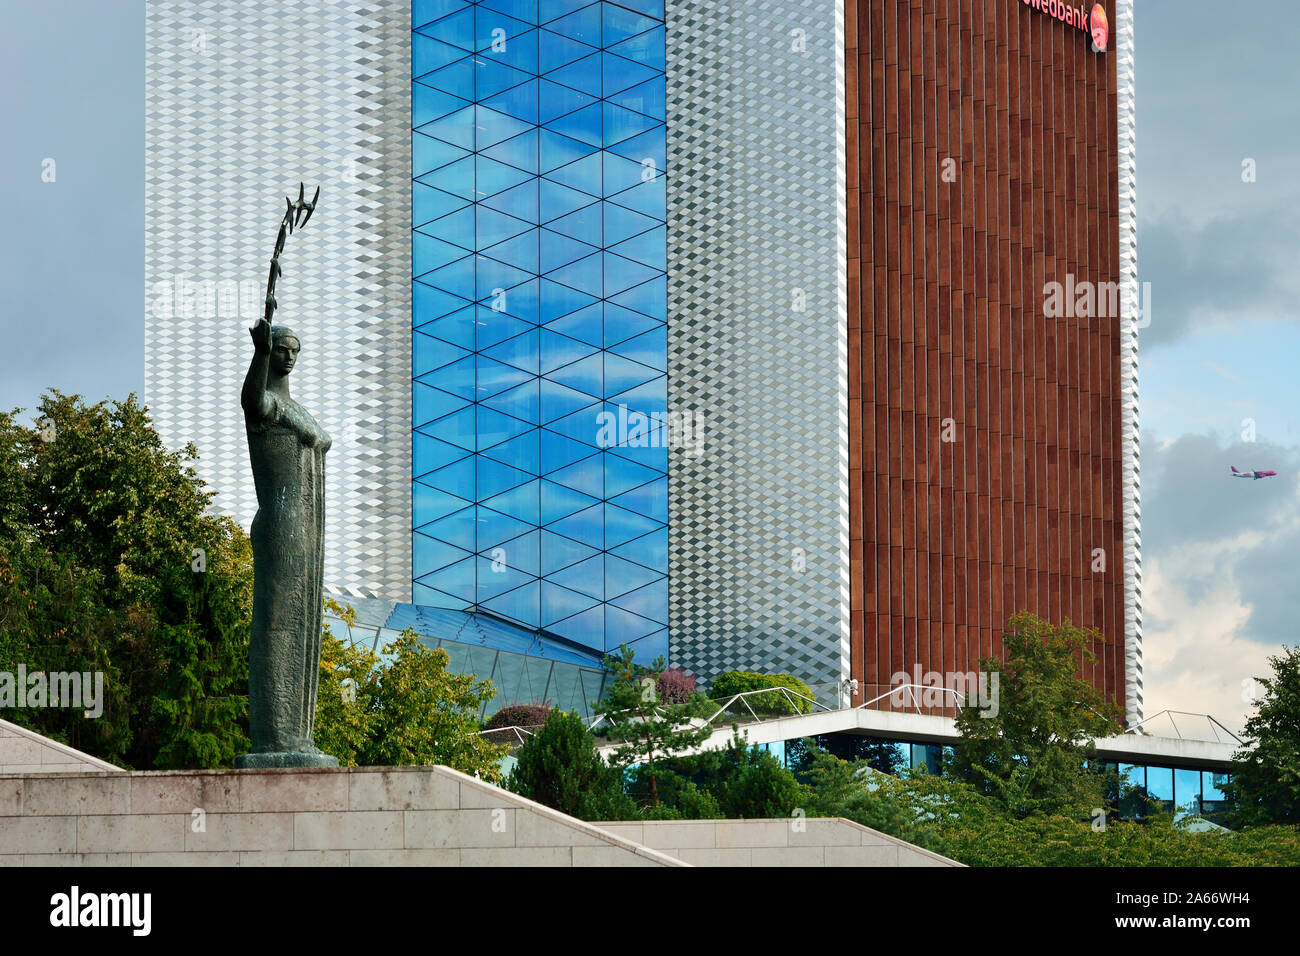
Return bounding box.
[244,392,332,753]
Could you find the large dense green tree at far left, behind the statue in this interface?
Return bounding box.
[0,392,252,767]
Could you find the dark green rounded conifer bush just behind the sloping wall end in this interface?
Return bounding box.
[506,710,637,819]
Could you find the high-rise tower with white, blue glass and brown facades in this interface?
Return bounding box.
[147,0,1140,714]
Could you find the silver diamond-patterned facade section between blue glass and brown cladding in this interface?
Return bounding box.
[667,0,849,702]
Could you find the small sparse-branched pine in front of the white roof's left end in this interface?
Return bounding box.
[595,644,712,808]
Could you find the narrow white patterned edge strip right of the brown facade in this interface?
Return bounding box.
[1115,0,1151,726]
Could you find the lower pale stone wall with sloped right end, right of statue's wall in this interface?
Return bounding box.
[599,819,962,866]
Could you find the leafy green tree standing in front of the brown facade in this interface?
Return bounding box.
[952,611,1119,817]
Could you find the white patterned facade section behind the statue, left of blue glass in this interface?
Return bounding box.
[144,0,411,600]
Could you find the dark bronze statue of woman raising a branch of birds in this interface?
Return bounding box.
[235,185,338,767]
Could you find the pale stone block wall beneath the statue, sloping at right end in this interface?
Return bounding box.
[0,767,683,866]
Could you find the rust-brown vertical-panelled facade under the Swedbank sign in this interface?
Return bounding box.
[845,0,1125,708]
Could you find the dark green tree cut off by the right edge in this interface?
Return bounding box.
[1223,646,1300,826]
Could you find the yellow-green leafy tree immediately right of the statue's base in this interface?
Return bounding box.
[315,601,507,783]
